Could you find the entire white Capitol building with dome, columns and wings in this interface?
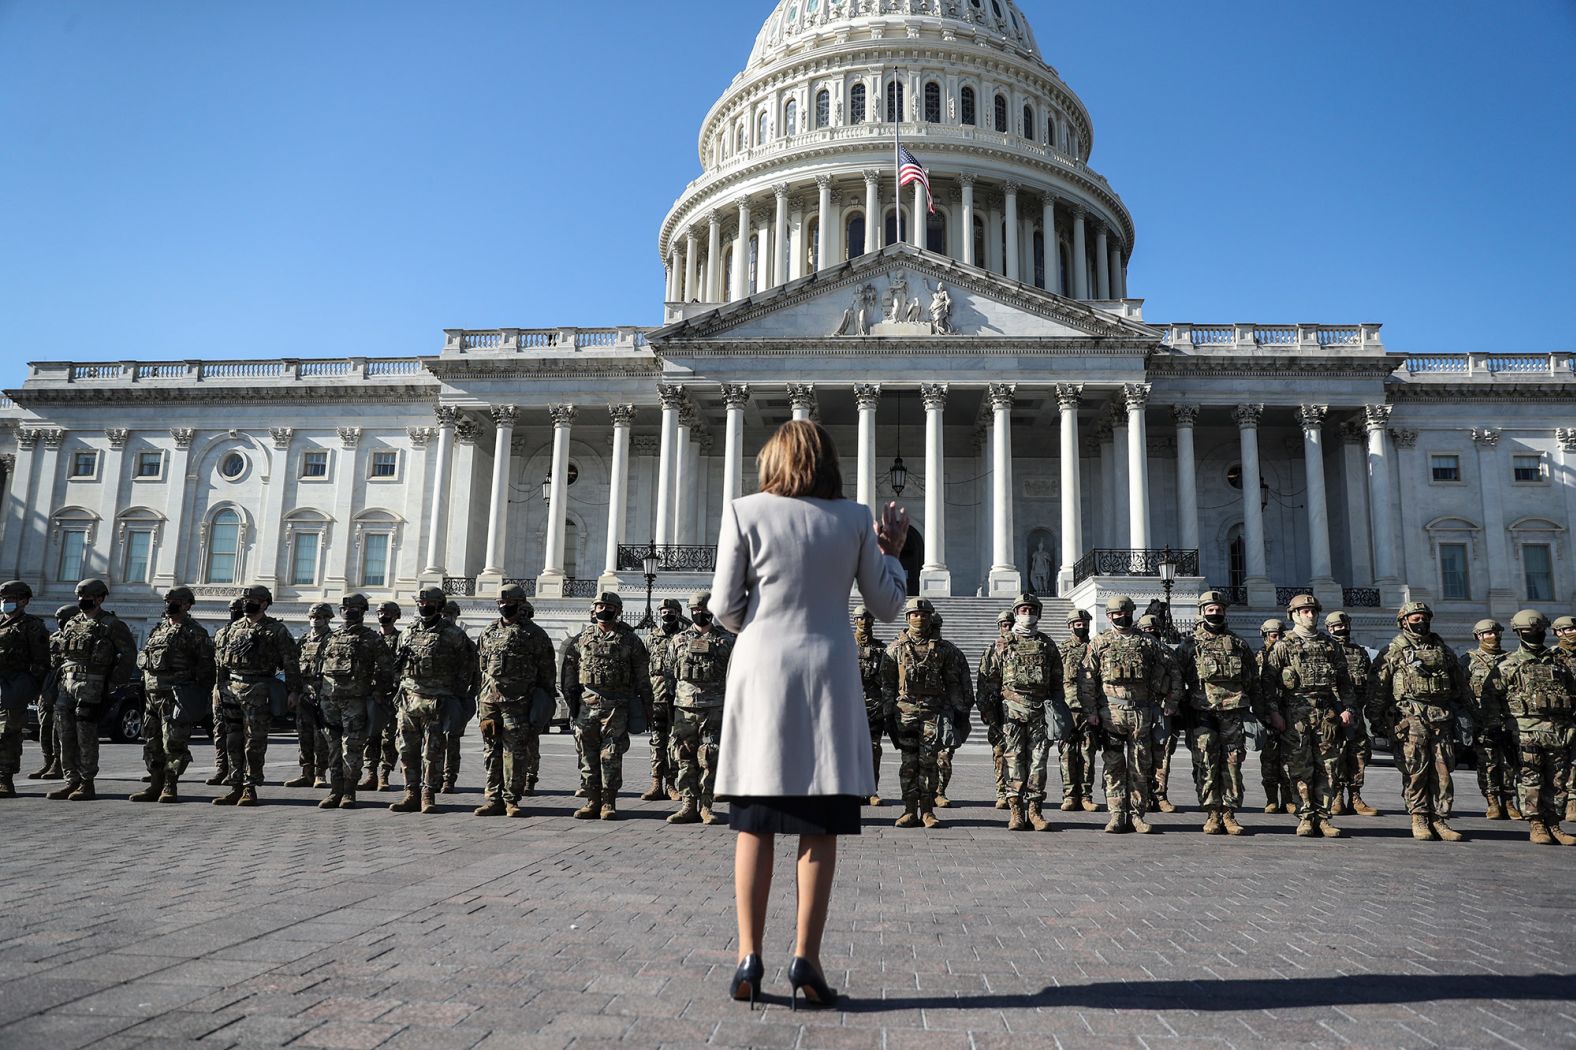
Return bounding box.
[0,0,1576,643]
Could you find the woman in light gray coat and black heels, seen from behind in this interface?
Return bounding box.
[711,421,908,1007]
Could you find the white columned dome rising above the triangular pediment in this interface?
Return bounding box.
[657,0,1135,310]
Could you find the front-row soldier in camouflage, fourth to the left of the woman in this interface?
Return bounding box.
[389,586,476,814]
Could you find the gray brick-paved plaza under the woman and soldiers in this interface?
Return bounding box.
[0,735,1576,1050]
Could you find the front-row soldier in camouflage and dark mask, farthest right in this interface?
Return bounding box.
[1483,609,1576,845]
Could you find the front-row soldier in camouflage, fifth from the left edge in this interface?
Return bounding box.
[315,594,394,809]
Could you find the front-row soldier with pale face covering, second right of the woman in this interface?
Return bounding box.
[979,593,1072,831]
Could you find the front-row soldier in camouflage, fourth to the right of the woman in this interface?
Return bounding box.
[1177,591,1267,836]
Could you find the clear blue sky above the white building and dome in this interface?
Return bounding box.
[0,0,1576,376]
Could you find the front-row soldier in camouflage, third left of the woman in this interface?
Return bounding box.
[473,583,558,817]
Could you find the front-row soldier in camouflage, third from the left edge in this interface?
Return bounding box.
[131,586,213,802]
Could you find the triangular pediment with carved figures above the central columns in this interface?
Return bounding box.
[649,244,1163,352]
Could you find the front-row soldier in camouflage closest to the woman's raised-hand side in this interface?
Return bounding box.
[881,598,972,828]
